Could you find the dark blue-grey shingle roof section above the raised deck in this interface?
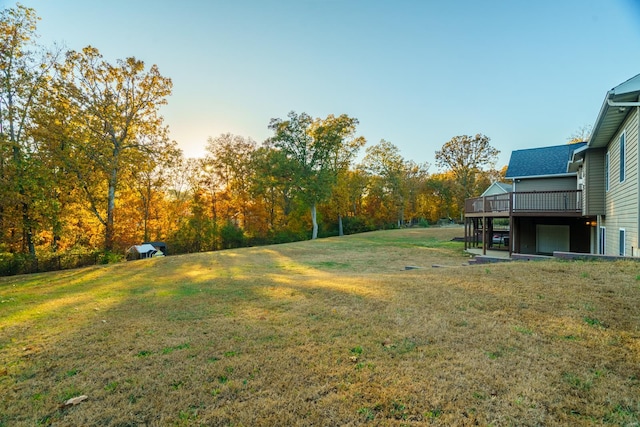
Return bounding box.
[506,142,587,178]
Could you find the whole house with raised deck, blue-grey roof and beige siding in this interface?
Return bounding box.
[465,75,640,257]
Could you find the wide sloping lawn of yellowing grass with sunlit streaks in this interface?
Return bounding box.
[0,228,640,426]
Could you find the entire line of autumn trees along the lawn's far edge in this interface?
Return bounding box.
[0,5,500,268]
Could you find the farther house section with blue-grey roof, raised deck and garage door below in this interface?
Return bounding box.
[465,143,591,255]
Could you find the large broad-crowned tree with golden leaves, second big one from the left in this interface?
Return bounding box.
[55,46,172,250]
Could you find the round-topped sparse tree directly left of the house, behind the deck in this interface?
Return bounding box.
[435,134,500,217]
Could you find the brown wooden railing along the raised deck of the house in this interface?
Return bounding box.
[465,190,582,216]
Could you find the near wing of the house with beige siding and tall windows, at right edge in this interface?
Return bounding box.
[571,74,640,257]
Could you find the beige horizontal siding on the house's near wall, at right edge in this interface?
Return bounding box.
[602,108,640,256]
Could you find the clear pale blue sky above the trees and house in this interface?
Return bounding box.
[0,0,640,173]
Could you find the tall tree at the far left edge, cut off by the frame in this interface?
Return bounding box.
[0,4,56,254]
